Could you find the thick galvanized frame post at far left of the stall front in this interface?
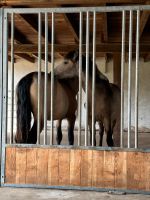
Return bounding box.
[1,12,8,184]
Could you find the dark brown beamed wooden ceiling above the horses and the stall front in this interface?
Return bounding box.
[0,0,150,62]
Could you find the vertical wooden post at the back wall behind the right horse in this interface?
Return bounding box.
[113,54,121,87]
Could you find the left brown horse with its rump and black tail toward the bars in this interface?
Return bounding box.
[15,72,78,145]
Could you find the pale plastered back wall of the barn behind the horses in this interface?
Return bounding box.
[8,58,150,130]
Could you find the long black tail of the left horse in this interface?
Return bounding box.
[15,73,33,143]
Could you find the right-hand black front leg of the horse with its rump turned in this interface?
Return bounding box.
[67,115,76,145]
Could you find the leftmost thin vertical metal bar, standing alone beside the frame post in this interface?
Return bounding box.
[10,13,14,144]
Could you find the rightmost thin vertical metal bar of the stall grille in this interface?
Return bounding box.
[135,10,140,148]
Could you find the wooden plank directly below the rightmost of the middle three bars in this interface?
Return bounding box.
[92,150,104,188]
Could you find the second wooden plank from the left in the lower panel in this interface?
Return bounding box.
[15,148,26,184]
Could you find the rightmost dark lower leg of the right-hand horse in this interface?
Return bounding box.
[104,119,114,147]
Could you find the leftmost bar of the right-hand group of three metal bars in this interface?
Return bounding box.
[120,10,126,147]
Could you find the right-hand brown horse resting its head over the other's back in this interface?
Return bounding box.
[54,51,120,146]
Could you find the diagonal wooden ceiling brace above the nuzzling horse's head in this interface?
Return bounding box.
[63,13,79,42]
